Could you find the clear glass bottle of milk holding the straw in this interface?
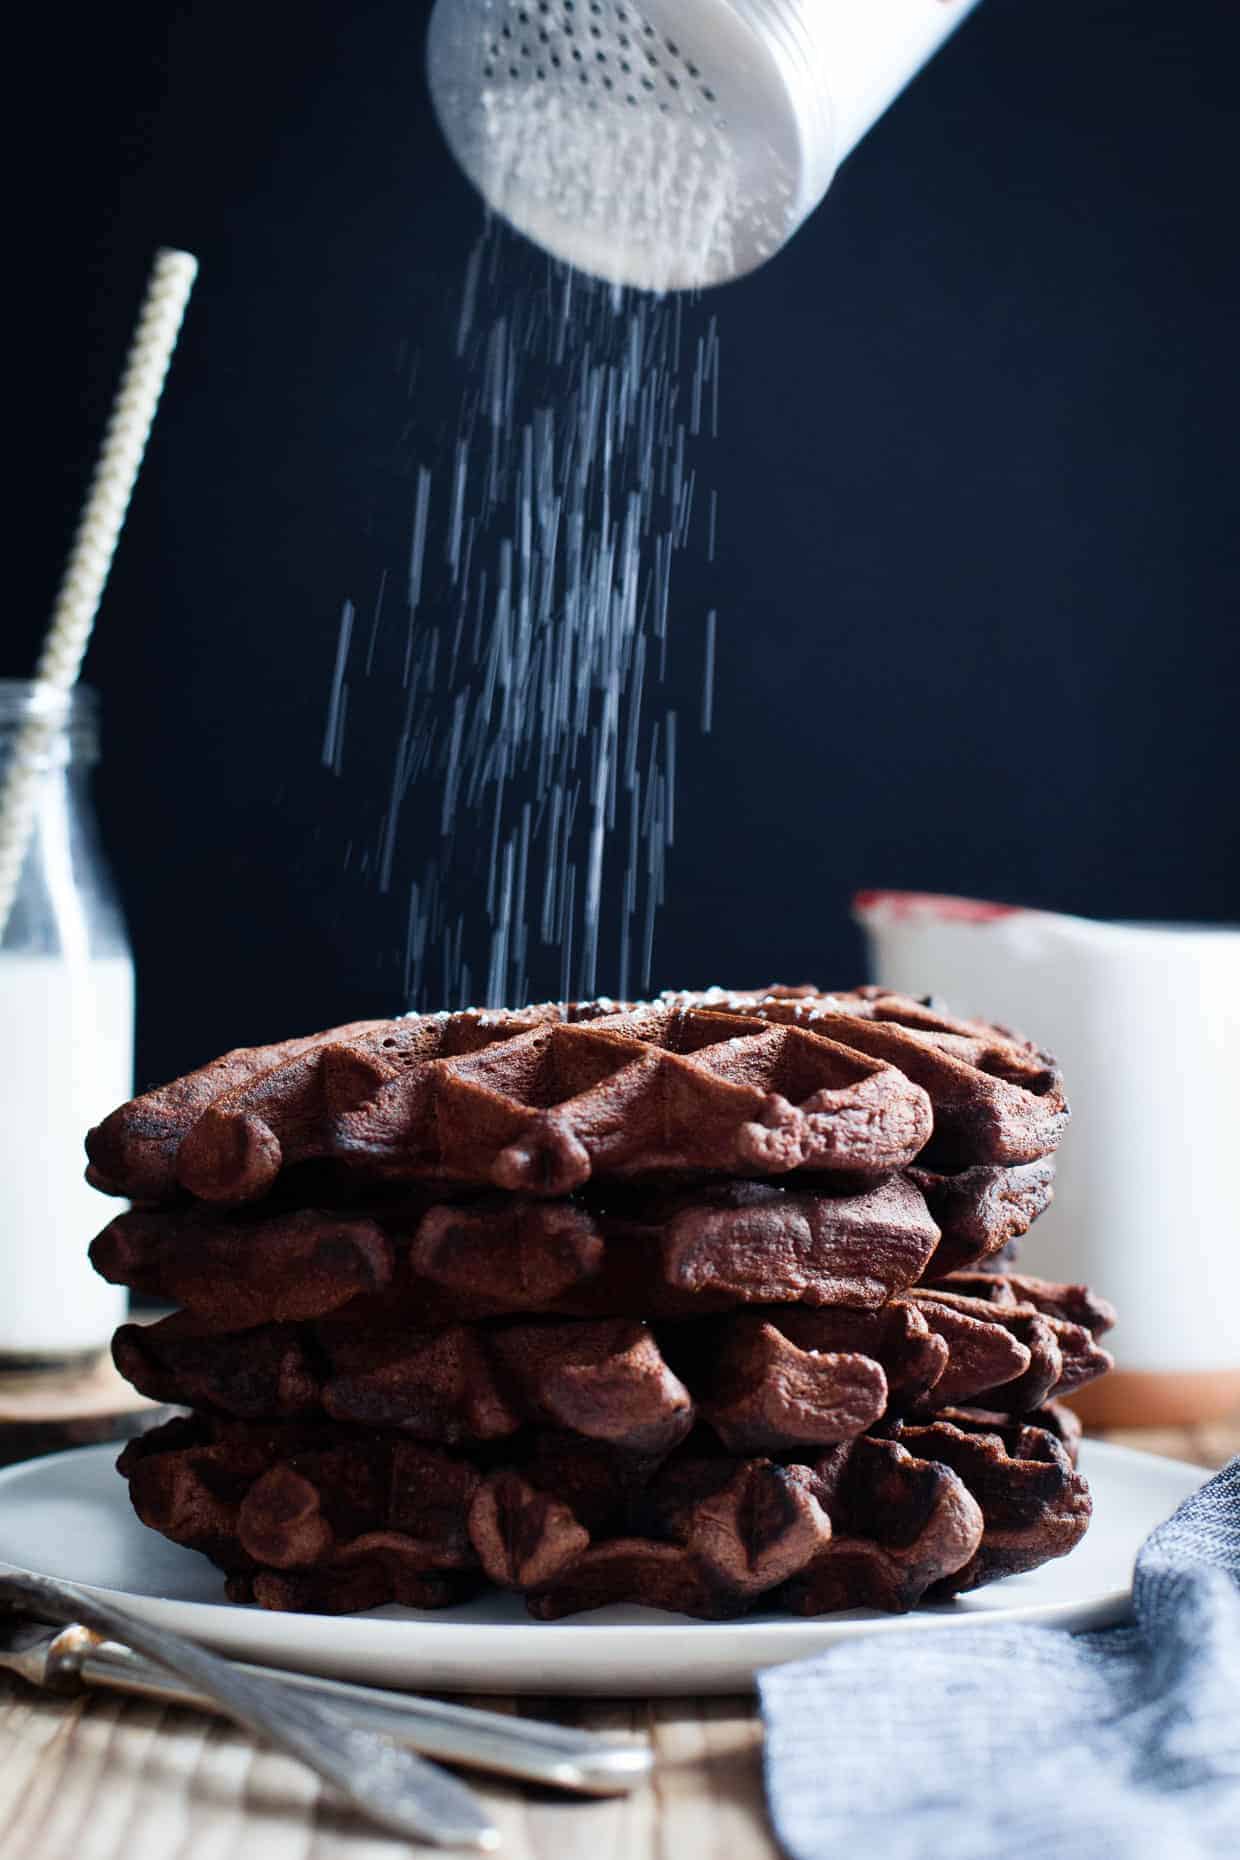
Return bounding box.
[0,679,134,1369]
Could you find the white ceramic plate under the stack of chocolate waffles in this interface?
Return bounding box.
[0,1442,1207,1696]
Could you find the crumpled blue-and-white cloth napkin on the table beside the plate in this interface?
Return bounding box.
[759,1458,1240,1860]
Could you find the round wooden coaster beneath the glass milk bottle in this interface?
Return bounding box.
[0,1350,175,1466]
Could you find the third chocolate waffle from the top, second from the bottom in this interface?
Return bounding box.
[113,1280,1110,1455]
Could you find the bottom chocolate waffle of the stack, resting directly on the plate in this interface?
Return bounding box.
[111,1412,1088,1618]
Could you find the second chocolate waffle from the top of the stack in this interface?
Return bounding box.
[91,1163,1052,1330]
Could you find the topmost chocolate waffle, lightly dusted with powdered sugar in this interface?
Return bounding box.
[87,990,1067,1205]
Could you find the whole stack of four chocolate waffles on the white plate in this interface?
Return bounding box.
[87,988,1112,1618]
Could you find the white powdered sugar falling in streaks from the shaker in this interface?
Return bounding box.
[322,221,719,1006]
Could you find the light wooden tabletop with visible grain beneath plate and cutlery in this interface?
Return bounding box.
[0,1417,1240,1860]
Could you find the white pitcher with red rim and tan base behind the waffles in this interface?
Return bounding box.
[855,891,1240,1425]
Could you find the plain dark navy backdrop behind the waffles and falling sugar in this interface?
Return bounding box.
[0,0,1240,1081]
